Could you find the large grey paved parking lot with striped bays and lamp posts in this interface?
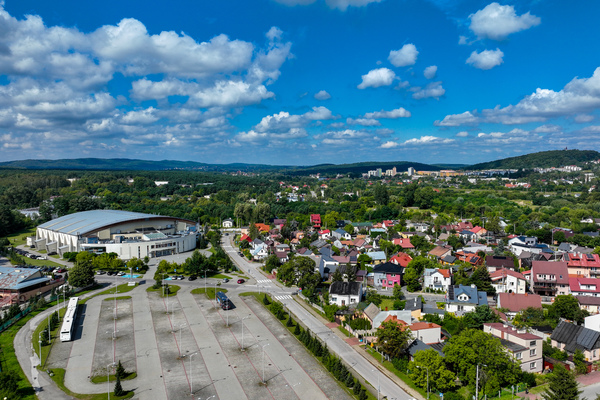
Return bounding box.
[46,284,351,400]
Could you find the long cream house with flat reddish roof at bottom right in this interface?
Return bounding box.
[483,322,544,372]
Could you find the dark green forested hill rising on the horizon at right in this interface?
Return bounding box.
[469,150,600,170]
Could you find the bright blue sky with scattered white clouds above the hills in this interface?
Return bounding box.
[0,0,600,165]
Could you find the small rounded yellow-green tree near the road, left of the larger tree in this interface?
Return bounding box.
[408,349,456,393]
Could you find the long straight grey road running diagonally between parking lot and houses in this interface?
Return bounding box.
[223,236,413,400]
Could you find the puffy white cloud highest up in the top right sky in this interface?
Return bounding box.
[469,2,541,40]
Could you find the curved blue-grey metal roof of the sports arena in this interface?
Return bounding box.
[38,210,181,235]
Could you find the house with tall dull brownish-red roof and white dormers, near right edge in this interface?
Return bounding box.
[531,261,569,296]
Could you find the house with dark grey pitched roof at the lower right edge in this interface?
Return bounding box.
[550,321,600,362]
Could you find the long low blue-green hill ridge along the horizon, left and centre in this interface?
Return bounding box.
[0,158,441,175]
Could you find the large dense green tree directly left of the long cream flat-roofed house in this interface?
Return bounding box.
[444,328,521,395]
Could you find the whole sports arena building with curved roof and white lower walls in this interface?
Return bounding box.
[35,210,198,260]
